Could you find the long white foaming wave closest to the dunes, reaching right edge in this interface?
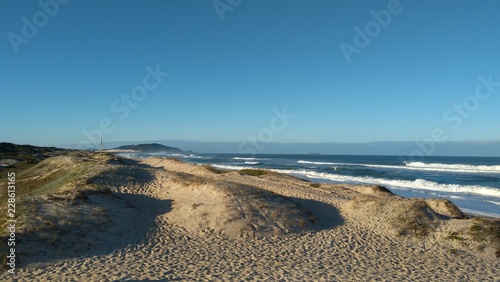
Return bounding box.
[273,169,500,198]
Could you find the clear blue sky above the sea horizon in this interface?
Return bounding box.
[0,0,500,149]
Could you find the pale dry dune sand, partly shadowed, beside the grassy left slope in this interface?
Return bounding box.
[0,155,500,281]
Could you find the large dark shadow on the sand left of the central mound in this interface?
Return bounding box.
[18,193,172,266]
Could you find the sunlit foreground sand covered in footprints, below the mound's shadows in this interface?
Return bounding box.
[8,169,500,281]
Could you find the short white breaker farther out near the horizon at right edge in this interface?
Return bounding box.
[405,162,500,173]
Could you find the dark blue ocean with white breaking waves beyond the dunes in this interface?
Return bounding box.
[115,153,500,218]
